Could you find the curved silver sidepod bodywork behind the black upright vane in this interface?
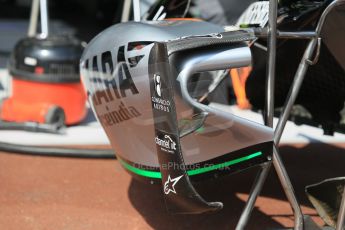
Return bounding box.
[80,21,273,168]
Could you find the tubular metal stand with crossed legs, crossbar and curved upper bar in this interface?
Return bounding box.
[236,0,345,230]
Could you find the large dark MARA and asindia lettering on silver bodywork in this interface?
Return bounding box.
[84,46,141,126]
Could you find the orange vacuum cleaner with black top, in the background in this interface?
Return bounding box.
[0,0,87,132]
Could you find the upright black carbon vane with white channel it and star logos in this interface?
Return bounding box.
[149,42,223,214]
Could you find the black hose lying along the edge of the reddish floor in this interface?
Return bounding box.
[0,142,116,159]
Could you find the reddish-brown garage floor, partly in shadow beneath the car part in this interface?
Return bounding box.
[0,144,345,230]
